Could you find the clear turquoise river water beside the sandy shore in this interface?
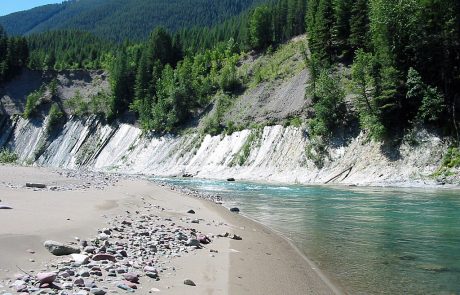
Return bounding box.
[155,178,460,294]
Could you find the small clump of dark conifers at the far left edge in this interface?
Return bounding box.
[0,26,29,83]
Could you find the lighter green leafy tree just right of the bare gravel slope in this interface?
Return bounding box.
[309,71,346,139]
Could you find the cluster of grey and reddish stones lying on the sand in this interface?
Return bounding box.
[0,195,244,295]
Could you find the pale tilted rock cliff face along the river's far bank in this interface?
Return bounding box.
[0,117,448,185]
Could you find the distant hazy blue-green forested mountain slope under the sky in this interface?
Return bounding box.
[0,0,266,41]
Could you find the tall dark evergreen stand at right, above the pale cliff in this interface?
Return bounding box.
[306,0,460,139]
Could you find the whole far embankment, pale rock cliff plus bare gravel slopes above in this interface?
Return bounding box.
[0,41,459,185]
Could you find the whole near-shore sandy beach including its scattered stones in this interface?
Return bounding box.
[0,166,340,294]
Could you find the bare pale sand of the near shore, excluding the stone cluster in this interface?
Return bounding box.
[0,166,341,294]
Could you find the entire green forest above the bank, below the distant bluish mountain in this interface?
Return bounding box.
[0,0,460,142]
